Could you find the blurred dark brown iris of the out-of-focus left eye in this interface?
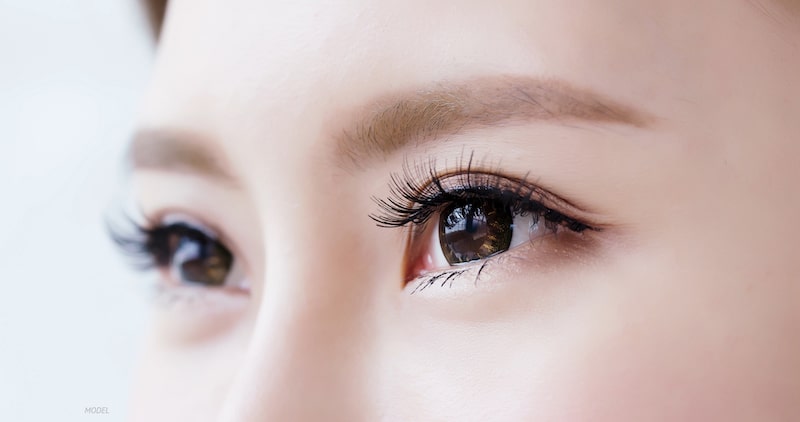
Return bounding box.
[169,229,233,286]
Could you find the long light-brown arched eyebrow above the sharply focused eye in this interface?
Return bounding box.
[336,76,654,168]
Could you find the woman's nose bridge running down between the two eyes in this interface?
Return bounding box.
[216,192,374,421]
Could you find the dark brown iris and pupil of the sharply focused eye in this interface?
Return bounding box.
[439,201,514,265]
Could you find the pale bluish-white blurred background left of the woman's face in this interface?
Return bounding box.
[0,0,152,422]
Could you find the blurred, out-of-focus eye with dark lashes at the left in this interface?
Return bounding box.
[111,214,245,300]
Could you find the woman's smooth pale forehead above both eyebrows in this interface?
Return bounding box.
[139,0,792,165]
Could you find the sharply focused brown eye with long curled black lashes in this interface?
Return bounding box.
[371,155,600,293]
